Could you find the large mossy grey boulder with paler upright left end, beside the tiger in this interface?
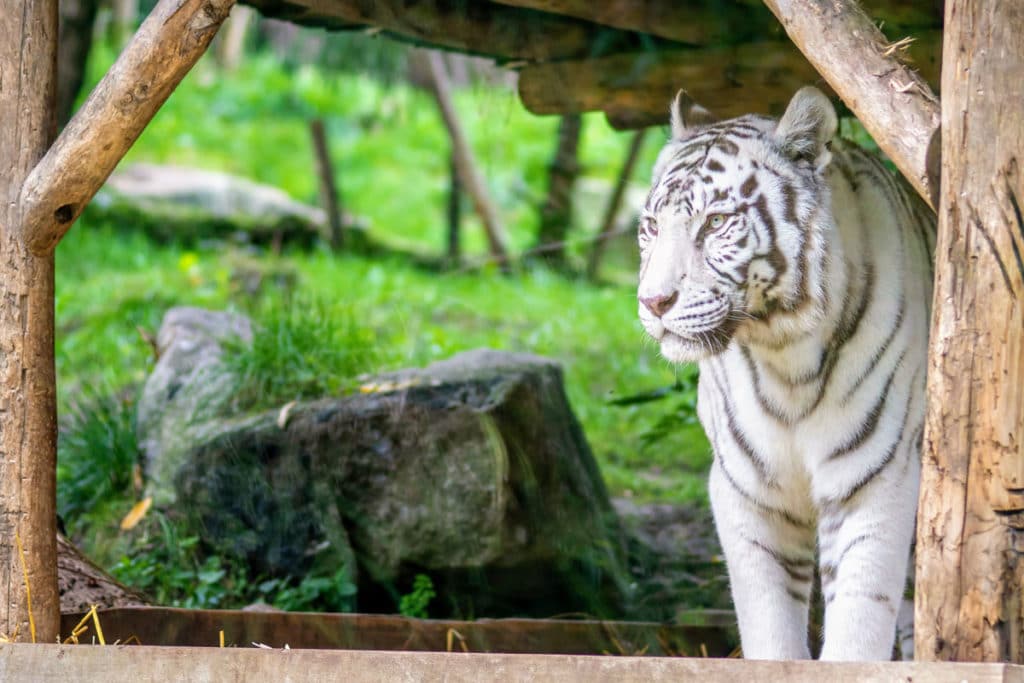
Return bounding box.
[138,308,626,616]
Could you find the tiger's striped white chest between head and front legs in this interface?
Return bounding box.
[697,325,916,511]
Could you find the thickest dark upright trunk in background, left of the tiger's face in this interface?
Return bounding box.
[537,114,583,268]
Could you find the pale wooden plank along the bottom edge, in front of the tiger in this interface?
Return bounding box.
[0,645,1024,683]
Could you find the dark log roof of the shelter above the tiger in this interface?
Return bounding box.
[239,0,942,128]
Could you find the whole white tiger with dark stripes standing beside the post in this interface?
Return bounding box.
[638,87,935,659]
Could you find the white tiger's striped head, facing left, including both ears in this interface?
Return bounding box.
[637,87,838,362]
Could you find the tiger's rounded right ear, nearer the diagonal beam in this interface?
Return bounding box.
[775,86,839,170]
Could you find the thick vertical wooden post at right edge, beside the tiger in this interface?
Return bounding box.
[914,0,1024,663]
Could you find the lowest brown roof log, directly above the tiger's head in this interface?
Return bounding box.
[519,32,941,128]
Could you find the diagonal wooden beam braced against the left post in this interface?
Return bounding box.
[20,0,234,255]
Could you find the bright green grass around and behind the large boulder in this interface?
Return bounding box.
[55,34,710,609]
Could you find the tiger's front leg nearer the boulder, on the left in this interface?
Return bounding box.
[709,458,814,659]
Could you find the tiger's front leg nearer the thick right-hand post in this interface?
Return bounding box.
[818,451,920,660]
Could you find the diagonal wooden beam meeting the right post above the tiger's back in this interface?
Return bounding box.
[764,0,948,209]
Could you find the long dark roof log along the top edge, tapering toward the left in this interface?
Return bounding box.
[241,0,671,60]
